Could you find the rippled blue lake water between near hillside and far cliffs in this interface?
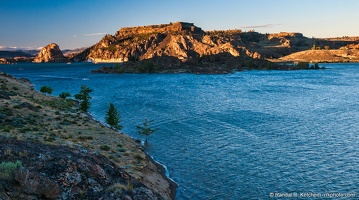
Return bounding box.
[0,63,359,199]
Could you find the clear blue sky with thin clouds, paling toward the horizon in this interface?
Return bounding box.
[0,0,359,50]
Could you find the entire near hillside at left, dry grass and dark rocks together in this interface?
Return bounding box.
[0,72,171,199]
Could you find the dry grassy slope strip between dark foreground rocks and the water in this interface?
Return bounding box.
[0,72,170,196]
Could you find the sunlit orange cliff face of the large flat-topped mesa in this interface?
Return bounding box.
[78,22,255,62]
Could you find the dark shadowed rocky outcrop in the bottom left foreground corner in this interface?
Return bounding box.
[0,136,163,199]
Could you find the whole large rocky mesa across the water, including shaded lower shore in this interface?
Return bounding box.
[73,22,353,73]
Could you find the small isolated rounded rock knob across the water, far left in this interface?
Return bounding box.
[33,43,67,63]
